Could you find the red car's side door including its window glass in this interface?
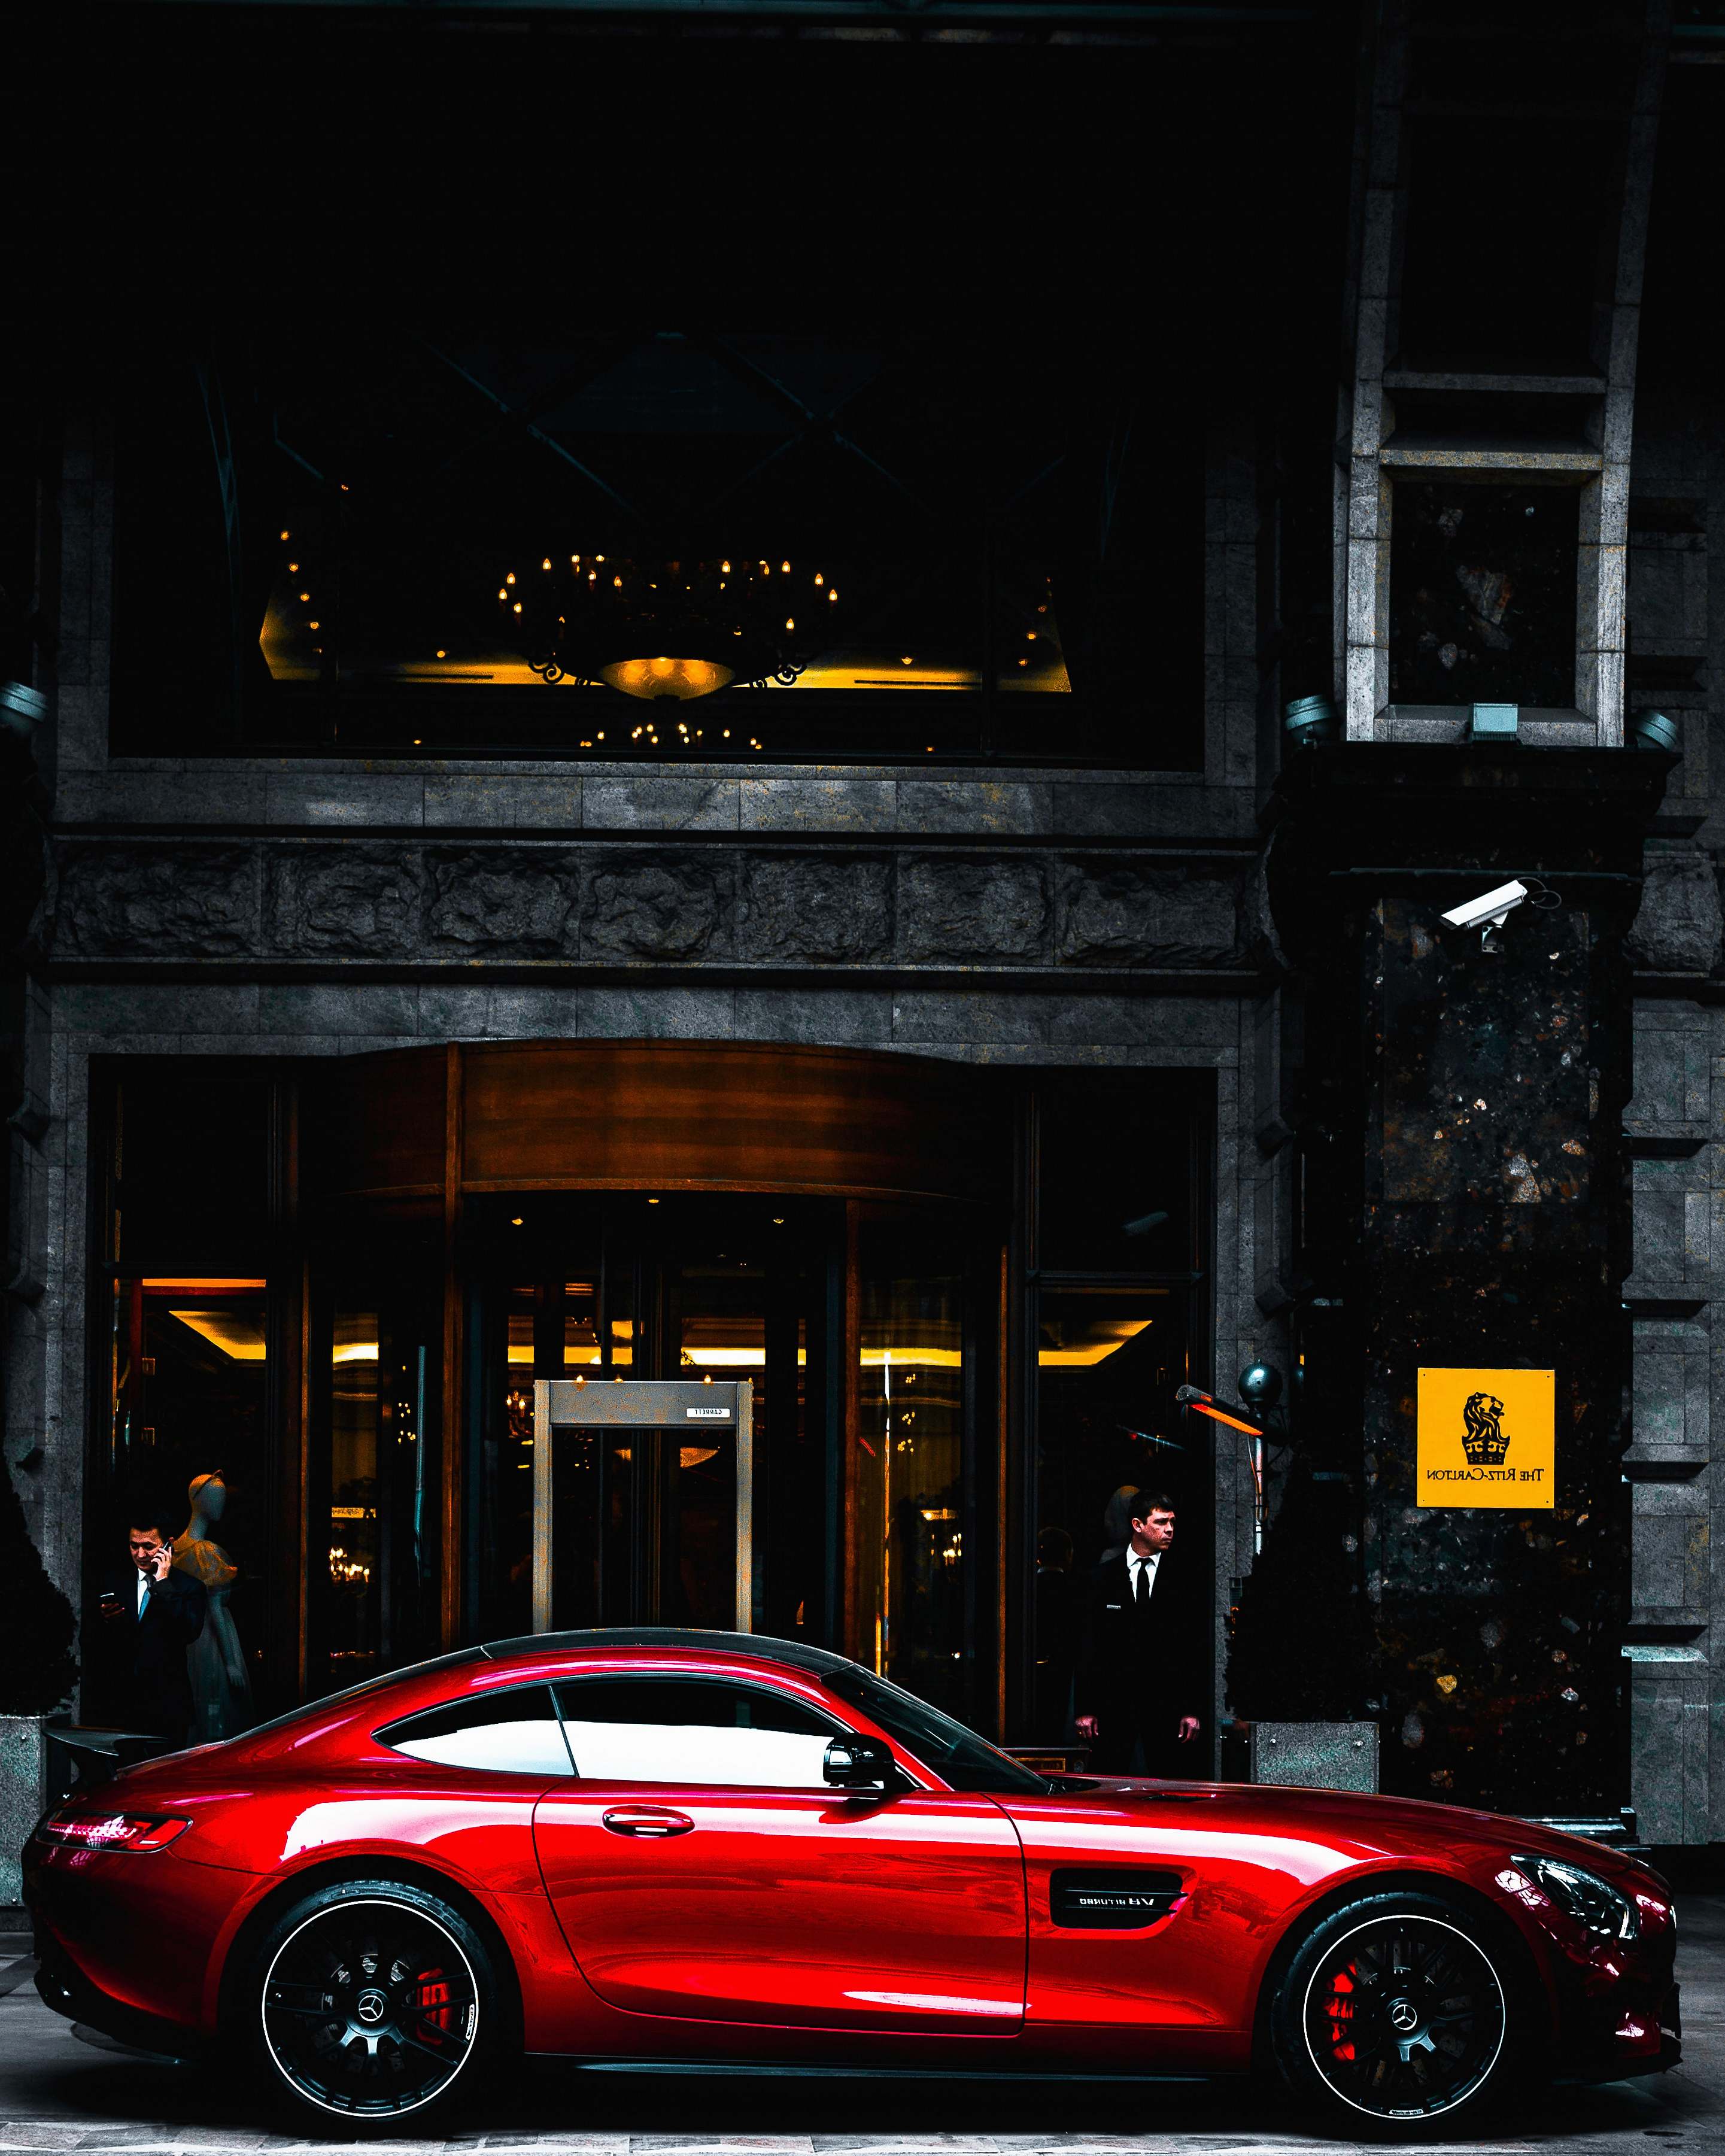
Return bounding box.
[533,1675,1027,2037]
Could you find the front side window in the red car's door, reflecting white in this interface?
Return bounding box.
[556,1677,848,1790]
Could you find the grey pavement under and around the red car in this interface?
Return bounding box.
[0,1895,1725,2156]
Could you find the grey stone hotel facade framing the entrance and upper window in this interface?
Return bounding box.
[4,0,1725,1844]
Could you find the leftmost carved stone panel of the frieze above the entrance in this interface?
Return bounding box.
[54,845,261,957]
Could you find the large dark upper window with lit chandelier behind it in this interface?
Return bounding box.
[114,321,1203,770]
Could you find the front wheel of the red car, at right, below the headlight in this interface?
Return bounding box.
[1270,1891,1546,2139]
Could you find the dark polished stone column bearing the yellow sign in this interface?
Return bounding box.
[1270,744,1674,1813]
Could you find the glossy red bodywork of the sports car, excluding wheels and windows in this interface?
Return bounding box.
[26,1634,1671,2072]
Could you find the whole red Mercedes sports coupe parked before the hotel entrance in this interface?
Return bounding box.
[26,1630,1678,2130]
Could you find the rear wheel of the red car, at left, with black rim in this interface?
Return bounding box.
[235,1880,502,2132]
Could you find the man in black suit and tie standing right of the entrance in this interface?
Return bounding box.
[1074,1490,1203,1779]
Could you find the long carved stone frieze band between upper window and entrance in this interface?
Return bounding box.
[43,834,1250,968]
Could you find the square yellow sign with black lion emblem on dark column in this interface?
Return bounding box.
[1414,1369,1557,1507]
